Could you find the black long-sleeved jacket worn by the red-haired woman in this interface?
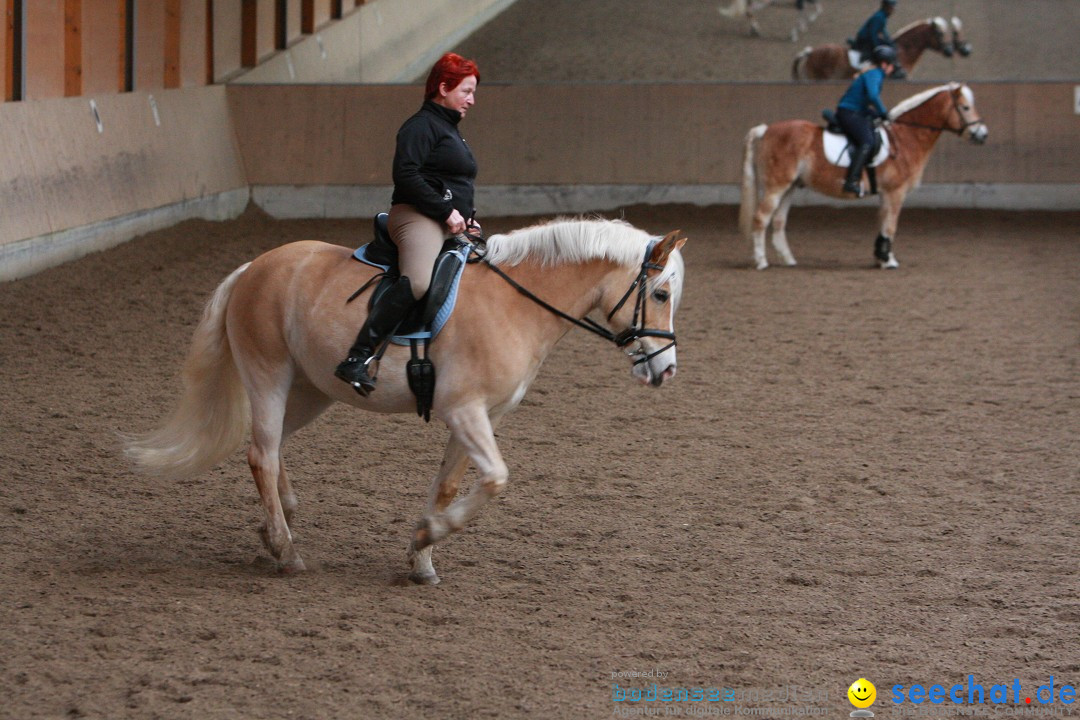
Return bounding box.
[391,100,477,222]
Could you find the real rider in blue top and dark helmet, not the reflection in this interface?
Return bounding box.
[836,45,896,198]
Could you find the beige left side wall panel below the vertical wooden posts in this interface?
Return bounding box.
[0,85,246,244]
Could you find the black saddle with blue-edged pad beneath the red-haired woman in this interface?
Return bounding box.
[346,213,472,422]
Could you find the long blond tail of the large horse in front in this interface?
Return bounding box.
[122,263,251,479]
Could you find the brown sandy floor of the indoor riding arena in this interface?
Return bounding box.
[0,0,1080,719]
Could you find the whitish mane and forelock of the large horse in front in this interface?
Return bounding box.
[487,218,684,301]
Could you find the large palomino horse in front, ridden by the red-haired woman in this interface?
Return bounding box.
[126,220,686,584]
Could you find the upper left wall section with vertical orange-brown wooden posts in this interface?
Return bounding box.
[0,0,369,100]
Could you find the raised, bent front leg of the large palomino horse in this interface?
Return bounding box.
[413,404,509,552]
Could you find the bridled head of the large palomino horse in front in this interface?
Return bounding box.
[605,230,686,388]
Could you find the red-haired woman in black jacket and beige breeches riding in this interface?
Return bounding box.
[334,53,480,396]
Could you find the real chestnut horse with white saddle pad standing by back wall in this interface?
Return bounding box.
[739,83,987,270]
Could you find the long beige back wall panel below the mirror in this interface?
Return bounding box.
[228,83,1080,186]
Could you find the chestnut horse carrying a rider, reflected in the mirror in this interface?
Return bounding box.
[792,17,971,80]
